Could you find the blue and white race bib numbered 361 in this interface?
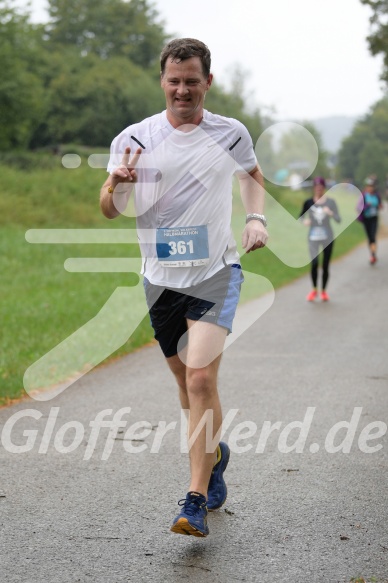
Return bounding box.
[156,225,209,267]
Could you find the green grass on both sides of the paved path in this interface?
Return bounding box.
[0,158,364,404]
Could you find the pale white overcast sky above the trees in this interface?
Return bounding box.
[18,0,383,121]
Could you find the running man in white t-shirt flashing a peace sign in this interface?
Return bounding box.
[100,38,268,537]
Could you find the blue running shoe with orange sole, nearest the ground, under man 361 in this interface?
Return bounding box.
[170,492,209,537]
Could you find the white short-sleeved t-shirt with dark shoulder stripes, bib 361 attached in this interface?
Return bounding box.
[108,110,257,288]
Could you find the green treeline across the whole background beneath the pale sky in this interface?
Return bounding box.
[0,0,388,186]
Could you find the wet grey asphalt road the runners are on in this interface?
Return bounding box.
[0,230,388,583]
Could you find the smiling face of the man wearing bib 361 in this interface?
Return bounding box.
[161,57,213,125]
